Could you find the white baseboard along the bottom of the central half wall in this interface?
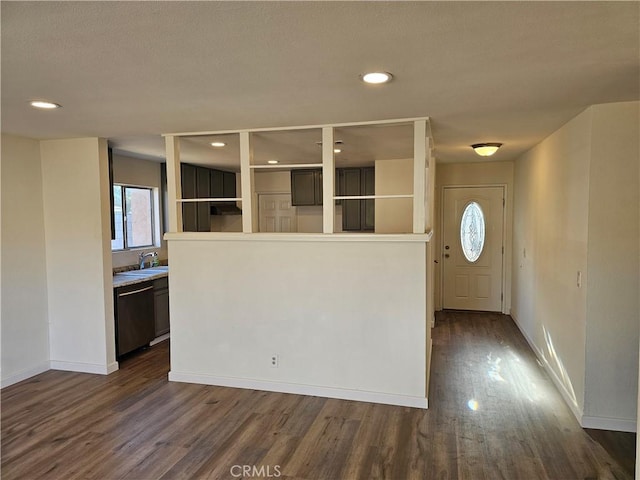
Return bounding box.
[169,371,428,409]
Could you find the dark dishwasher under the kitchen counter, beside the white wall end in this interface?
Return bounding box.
[114,281,155,358]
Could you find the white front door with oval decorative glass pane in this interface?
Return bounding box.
[442,187,504,312]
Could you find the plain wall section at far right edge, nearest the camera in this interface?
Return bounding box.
[584,102,640,428]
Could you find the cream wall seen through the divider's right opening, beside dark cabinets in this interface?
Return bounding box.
[375,158,413,233]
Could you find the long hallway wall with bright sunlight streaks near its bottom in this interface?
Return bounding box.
[511,112,591,416]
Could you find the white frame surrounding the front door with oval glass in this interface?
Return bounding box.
[436,183,511,315]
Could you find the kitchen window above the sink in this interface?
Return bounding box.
[111,185,154,250]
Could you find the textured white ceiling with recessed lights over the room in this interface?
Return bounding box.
[0,1,640,162]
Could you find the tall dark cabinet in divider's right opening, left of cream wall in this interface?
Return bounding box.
[338,167,375,232]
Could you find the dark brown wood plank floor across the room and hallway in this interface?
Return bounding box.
[1,312,633,480]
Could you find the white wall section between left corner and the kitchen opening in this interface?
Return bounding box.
[40,138,117,374]
